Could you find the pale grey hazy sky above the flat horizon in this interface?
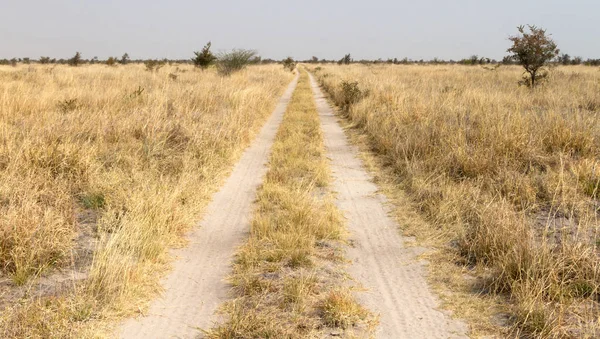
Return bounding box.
[0,0,600,59]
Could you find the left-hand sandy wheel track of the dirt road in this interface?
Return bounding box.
[120,76,298,339]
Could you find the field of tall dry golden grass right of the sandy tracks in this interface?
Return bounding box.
[316,65,600,337]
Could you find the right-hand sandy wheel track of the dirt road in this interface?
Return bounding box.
[311,75,467,339]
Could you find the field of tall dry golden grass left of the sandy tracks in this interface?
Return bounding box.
[0,65,292,338]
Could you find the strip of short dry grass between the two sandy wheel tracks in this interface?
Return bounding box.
[208,72,369,338]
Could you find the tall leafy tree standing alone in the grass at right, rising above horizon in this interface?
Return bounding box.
[507,25,560,88]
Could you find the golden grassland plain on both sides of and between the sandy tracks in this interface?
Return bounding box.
[0,63,600,338]
